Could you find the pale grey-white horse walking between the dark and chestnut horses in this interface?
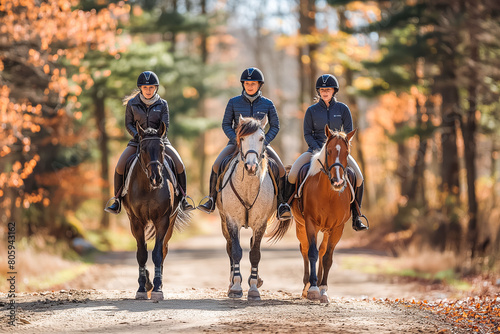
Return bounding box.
[217,116,276,300]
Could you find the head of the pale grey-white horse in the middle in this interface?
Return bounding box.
[236,115,267,175]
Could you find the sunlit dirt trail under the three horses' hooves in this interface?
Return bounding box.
[0,231,465,334]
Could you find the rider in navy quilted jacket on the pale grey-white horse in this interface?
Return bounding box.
[198,67,292,220]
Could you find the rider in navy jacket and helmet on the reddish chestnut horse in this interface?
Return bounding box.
[285,74,368,231]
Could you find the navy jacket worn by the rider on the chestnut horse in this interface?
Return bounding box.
[304,99,352,152]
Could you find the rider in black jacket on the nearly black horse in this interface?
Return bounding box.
[104,71,195,214]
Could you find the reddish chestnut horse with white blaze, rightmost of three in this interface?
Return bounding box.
[272,125,356,303]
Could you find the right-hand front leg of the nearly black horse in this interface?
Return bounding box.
[151,217,170,300]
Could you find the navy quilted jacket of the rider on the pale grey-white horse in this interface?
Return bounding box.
[222,95,280,145]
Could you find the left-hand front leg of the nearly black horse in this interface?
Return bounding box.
[129,216,152,299]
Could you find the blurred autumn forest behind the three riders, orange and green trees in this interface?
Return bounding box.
[0,0,500,288]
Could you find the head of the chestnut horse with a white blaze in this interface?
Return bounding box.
[320,124,356,191]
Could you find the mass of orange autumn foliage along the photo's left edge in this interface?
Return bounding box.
[0,0,128,235]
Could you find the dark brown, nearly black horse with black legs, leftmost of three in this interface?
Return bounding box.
[123,122,190,300]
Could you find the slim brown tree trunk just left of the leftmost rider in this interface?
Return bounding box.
[92,82,110,228]
